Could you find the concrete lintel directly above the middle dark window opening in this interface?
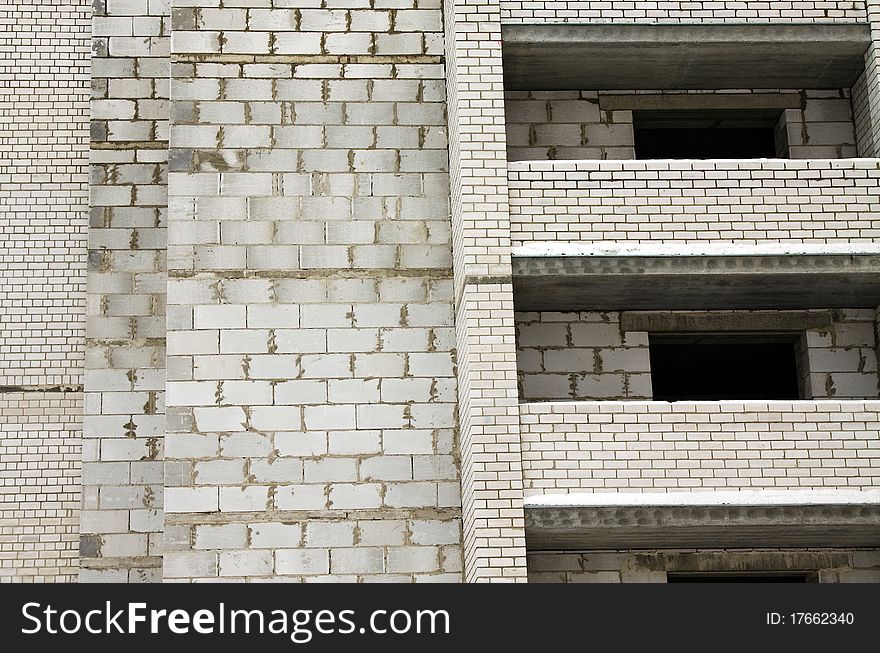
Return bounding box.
[620,311,833,333]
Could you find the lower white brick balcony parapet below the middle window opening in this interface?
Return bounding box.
[520,400,880,496]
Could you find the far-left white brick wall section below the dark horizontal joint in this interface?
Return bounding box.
[0,391,82,583]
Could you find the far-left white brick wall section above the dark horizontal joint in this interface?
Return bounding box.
[0,0,91,386]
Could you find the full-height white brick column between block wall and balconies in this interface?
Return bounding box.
[445,0,526,581]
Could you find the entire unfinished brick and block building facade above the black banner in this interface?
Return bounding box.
[0,0,880,582]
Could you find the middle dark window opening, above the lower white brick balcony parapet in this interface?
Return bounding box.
[649,334,802,401]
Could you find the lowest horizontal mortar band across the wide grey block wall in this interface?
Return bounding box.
[165,504,461,526]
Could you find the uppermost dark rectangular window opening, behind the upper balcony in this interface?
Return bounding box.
[633,111,787,159]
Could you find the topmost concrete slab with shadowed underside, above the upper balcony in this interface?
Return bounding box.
[501,23,871,90]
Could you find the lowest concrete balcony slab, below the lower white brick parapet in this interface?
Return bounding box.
[525,504,880,551]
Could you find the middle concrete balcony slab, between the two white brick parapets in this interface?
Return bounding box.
[513,254,880,311]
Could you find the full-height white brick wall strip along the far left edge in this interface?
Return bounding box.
[0,0,90,582]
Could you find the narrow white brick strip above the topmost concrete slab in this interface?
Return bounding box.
[501,0,867,23]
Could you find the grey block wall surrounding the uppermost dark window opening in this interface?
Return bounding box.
[505,89,861,161]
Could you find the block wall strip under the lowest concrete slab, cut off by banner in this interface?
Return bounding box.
[529,549,880,583]
